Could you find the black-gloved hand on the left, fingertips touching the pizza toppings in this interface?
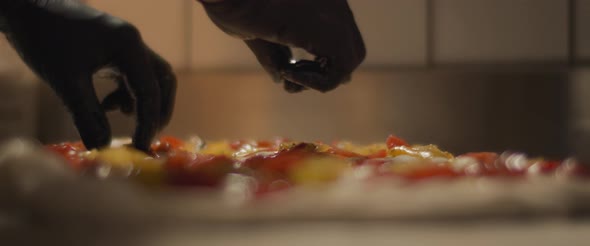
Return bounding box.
[0,0,176,151]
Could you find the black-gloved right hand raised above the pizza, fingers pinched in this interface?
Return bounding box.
[200,0,365,92]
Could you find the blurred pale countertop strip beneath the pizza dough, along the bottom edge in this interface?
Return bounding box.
[0,220,590,246]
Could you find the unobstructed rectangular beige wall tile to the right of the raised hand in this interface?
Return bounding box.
[434,0,567,63]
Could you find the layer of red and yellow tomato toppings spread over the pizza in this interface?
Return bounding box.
[46,135,590,195]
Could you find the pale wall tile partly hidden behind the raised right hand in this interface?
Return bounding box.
[192,0,426,68]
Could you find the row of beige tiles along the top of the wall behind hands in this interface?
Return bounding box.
[89,0,590,69]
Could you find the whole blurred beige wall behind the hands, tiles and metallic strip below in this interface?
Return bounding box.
[0,0,590,158]
